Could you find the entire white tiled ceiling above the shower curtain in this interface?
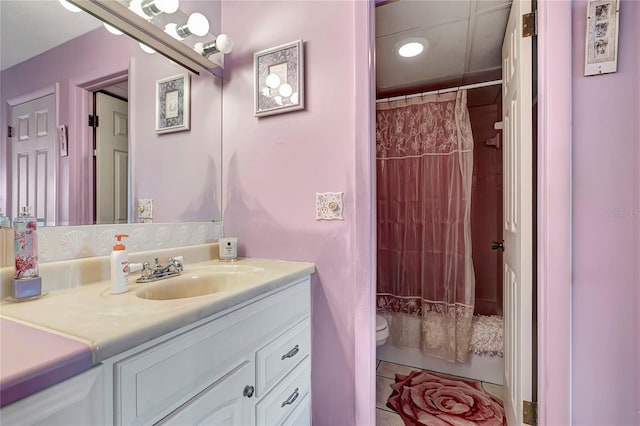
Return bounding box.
[376,0,511,106]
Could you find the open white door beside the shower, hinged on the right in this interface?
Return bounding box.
[502,0,533,425]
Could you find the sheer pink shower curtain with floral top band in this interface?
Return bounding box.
[376,91,475,362]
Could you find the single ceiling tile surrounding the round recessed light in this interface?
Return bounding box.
[376,21,467,89]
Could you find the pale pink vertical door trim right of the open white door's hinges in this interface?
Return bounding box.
[537,0,572,425]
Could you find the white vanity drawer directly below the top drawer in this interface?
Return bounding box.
[256,357,311,426]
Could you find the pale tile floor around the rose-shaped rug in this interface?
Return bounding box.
[376,360,502,426]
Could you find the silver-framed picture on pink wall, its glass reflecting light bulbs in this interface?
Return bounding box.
[253,40,304,117]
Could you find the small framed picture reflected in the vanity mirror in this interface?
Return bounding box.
[156,74,190,133]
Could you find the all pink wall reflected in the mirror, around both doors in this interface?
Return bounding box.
[0,1,222,224]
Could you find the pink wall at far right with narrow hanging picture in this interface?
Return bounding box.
[572,0,640,425]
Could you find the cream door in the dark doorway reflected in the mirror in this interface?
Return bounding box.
[95,93,129,224]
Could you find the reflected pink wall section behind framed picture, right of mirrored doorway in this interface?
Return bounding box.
[129,53,222,222]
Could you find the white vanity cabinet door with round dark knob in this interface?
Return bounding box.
[157,361,254,426]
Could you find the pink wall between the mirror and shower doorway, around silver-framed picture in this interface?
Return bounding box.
[222,0,374,425]
